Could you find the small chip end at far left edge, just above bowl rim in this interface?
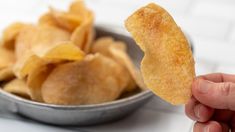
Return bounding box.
[0,67,15,82]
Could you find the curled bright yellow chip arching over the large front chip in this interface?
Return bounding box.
[14,42,85,78]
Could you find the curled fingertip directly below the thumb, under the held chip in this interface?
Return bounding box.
[185,98,214,122]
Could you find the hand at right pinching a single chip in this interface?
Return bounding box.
[185,73,235,132]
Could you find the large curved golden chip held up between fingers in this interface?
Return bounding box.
[125,4,195,105]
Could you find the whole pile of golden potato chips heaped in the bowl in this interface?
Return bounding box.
[0,0,143,105]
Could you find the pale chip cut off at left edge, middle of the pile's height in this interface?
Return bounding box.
[0,46,15,70]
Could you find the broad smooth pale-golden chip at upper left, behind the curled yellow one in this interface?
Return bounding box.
[15,25,70,59]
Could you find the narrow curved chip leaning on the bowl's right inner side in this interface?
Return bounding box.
[92,37,145,91]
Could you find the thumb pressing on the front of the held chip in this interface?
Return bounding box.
[192,79,235,110]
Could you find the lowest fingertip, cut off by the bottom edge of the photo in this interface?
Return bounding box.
[193,121,229,132]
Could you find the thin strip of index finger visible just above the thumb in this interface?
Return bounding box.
[198,73,235,82]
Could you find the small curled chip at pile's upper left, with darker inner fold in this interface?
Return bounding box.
[2,22,26,49]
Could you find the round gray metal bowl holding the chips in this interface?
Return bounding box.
[0,26,153,125]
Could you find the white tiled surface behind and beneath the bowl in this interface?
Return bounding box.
[0,0,235,132]
